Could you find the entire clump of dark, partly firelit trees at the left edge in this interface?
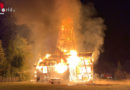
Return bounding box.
[0,15,32,80]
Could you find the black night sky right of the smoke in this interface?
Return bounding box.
[0,0,130,72]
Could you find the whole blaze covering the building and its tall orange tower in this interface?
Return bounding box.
[36,20,94,82]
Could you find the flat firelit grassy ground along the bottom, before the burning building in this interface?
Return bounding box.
[0,80,130,90]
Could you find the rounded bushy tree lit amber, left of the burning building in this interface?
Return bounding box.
[8,35,32,80]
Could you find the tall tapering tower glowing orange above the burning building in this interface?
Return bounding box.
[57,19,75,53]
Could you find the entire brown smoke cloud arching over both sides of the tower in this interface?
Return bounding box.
[8,0,104,63]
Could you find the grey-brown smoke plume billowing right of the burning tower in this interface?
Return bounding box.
[76,3,106,62]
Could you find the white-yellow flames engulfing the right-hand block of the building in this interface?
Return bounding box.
[67,50,93,81]
